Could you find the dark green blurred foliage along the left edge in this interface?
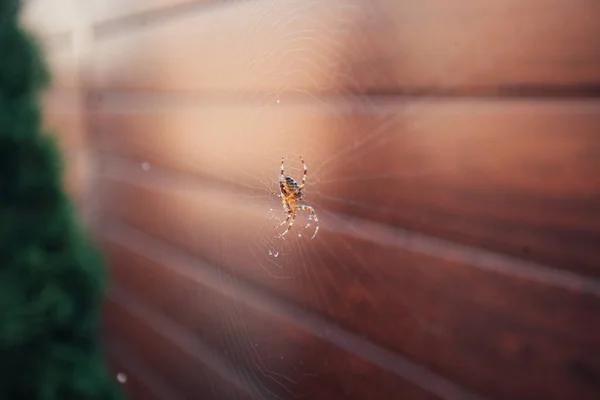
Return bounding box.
[0,0,122,400]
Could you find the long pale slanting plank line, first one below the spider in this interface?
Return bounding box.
[102,219,483,400]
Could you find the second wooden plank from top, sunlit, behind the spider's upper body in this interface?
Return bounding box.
[92,98,600,277]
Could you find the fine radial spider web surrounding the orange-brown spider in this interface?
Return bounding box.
[98,1,552,398]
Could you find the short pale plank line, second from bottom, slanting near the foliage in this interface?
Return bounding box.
[107,282,277,399]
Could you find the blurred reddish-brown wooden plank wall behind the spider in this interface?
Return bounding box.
[24,0,600,399]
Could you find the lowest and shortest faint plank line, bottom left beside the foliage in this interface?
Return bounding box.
[105,338,182,400]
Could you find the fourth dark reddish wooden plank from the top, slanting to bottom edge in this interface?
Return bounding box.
[106,231,451,400]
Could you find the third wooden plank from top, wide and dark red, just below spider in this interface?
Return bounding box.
[100,176,600,399]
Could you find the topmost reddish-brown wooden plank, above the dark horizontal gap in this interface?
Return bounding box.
[91,0,600,92]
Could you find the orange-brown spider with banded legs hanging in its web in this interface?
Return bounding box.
[279,156,319,239]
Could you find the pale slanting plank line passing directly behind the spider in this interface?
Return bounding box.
[97,152,600,297]
